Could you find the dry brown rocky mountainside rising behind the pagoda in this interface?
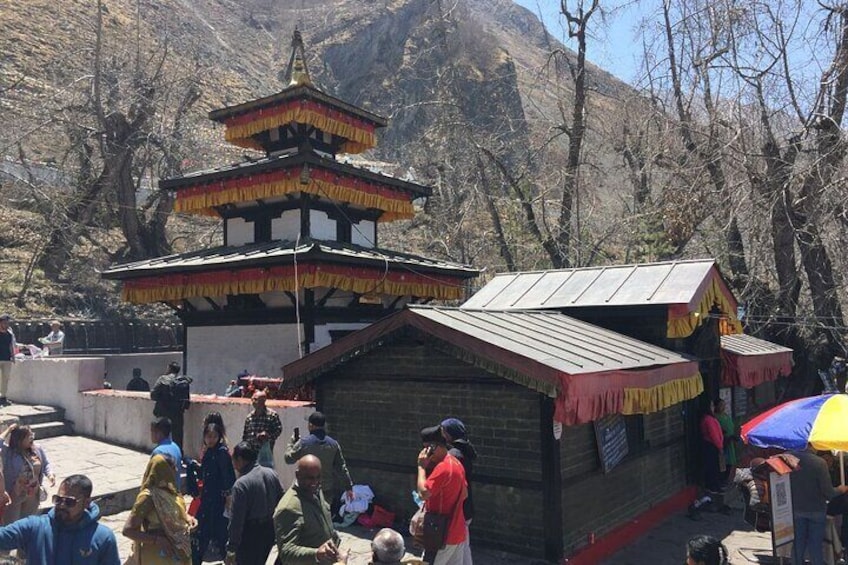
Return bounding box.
[0,0,630,318]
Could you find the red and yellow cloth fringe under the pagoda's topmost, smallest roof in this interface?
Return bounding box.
[224,100,377,153]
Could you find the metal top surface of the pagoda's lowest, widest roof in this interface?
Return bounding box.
[101,240,480,279]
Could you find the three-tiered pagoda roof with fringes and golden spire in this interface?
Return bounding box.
[103,31,479,311]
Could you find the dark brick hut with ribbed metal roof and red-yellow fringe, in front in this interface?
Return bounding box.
[285,306,702,559]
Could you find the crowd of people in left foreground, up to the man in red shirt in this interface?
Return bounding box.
[0,356,476,565]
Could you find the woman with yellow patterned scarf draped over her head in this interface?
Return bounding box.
[123,455,196,565]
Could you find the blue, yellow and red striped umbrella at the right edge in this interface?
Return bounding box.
[740,394,848,484]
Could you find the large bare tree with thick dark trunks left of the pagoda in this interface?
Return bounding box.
[40,2,200,278]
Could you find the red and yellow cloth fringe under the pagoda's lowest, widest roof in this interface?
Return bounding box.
[121,263,463,304]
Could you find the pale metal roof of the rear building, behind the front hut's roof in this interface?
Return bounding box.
[462,259,715,310]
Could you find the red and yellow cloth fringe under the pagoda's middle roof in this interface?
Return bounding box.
[174,167,415,222]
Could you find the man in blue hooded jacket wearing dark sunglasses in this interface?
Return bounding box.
[0,475,121,565]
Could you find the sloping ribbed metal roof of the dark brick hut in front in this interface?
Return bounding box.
[409,306,691,375]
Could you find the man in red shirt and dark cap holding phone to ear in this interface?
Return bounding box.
[416,426,471,565]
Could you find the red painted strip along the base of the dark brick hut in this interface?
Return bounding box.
[563,486,698,565]
